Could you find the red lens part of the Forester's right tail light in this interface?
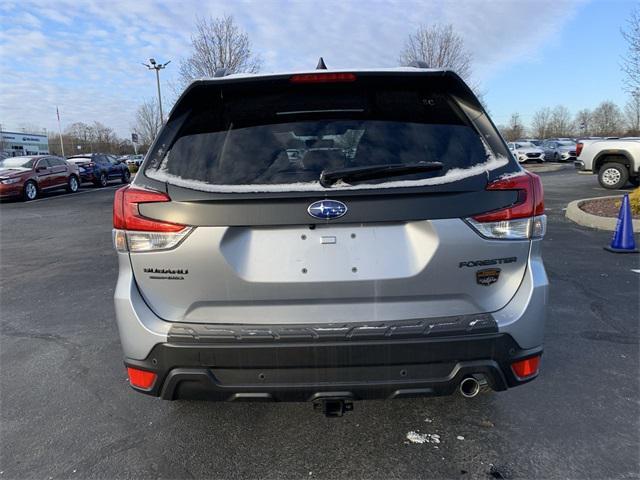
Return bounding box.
[473,172,544,222]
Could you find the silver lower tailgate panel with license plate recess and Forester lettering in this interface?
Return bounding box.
[131,219,530,324]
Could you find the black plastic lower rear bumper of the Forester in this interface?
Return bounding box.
[125,333,542,402]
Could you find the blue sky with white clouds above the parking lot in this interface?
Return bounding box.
[0,0,635,136]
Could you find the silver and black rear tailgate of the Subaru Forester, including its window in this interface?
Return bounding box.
[130,72,530,324]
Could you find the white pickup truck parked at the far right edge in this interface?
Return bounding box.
[573,137,640,190]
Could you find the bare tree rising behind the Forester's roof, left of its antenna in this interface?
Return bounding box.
[179,16,262,87]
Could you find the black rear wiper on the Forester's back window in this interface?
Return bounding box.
[320,162,443,188]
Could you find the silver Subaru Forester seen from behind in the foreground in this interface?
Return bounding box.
[113,67,548,415]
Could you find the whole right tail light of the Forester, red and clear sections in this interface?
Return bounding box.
[467,172,547,240]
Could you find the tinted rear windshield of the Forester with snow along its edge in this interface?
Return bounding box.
[145,82,507,192]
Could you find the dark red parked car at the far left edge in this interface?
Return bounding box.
[0,155,80,200]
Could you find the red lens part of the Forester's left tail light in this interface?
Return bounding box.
[113,186,185,232]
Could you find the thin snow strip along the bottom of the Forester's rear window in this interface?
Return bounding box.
[145,155,509,193]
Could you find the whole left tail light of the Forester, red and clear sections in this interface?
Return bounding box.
[113,186,192,252]
